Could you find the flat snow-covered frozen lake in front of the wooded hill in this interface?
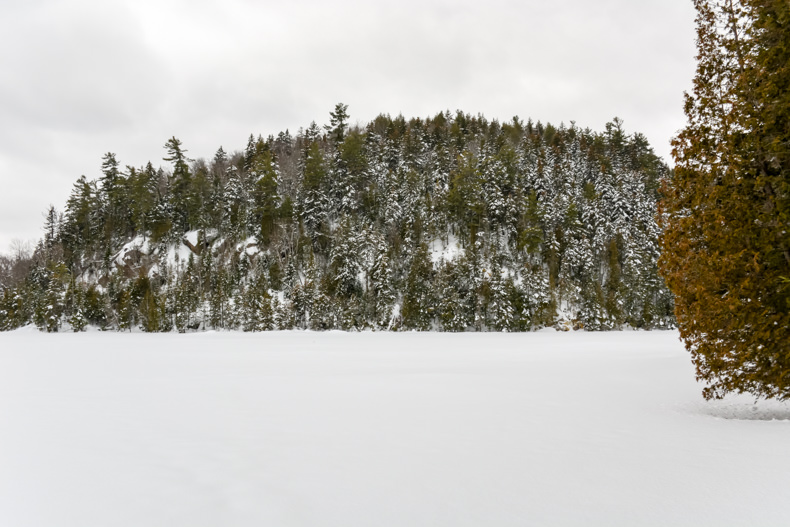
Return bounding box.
[0,330,790,527]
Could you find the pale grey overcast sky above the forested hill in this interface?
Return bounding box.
[0,0,695,252]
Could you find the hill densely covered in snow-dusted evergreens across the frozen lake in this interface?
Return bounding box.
[0,104,675,332]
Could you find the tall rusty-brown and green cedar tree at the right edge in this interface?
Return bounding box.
[660,0,790,400]
